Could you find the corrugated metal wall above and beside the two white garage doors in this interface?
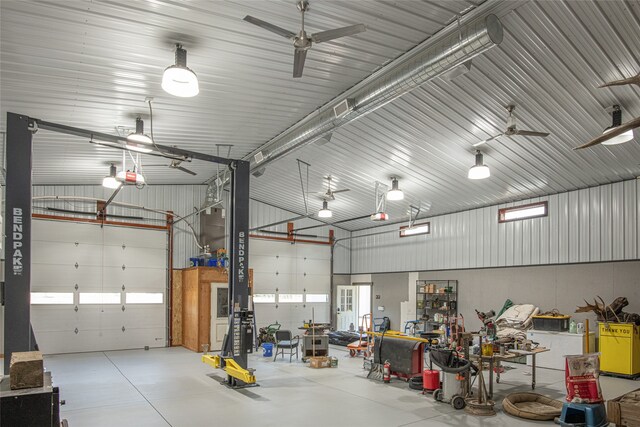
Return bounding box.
[33,185,350,273]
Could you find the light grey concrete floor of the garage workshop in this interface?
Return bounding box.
[45,347,639,427]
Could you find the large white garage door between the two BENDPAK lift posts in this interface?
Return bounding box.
[31,219,168,354]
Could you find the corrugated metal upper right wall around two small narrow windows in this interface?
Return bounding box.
[351,180,640,274]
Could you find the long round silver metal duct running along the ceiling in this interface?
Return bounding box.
[245,15,503,172]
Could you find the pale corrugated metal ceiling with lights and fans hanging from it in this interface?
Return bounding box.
[0,0,640,229]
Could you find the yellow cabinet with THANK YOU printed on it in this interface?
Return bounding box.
[599,322,640,376]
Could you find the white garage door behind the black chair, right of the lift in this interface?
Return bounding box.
[249,239,331,335]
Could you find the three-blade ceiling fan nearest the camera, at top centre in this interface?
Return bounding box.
[244,0,366,78]
